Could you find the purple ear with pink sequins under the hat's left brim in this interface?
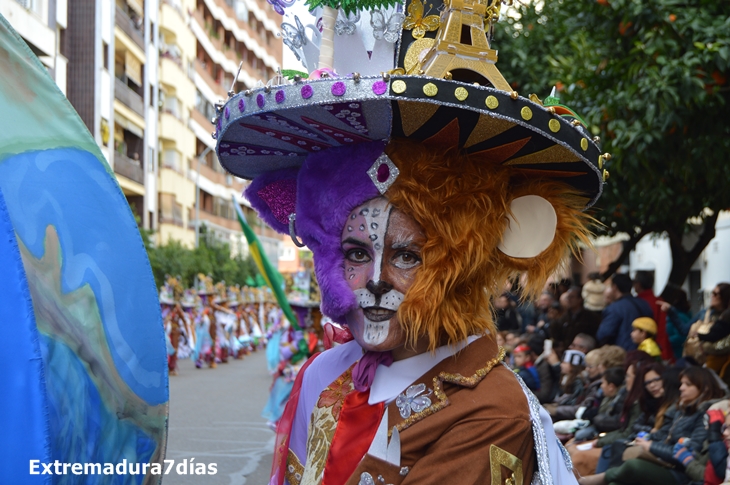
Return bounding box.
[244,168,299,234]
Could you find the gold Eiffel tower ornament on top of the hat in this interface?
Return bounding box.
[404,0,512,92]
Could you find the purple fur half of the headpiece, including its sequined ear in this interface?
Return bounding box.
[245,142,385,323]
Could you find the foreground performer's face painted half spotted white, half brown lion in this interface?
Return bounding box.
[342,197,425,351]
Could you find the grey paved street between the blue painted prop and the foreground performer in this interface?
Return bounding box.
[163,351,274,485]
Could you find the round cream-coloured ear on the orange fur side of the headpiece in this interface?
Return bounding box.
[497,195,558,258]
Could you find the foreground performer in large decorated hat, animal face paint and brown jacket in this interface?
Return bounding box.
[210,0,604,485]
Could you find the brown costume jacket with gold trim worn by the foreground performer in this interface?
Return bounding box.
[287,337,536,485]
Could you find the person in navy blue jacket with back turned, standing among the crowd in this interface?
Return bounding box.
[596,274,654,351]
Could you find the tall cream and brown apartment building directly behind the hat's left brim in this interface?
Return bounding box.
[158,0,282,262]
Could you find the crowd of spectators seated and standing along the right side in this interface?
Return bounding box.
[495,272,730,485]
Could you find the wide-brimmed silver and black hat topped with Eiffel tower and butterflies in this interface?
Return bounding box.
[214,0,608,206]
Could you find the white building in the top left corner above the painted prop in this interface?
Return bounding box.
[0,0,68,94]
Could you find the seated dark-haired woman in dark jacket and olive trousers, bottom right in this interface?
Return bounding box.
[580,367,724,485]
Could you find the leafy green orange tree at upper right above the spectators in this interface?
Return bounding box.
[495,0,730,297]
